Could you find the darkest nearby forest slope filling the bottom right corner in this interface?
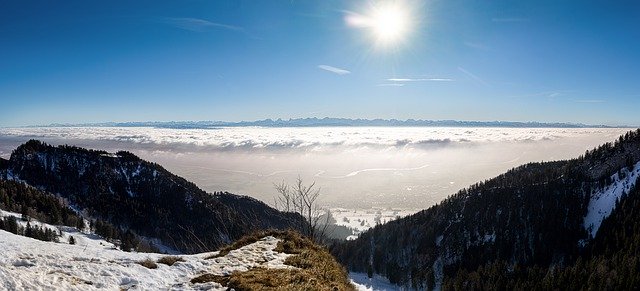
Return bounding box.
[442,181,640,290]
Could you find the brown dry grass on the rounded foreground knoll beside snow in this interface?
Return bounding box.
[192,231,354,291]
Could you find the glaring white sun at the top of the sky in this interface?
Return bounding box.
[345,1,413,47]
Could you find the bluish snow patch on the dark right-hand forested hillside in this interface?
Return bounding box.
[584,162,640,237]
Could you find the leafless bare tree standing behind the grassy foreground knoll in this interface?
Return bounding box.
[274,176,329,242]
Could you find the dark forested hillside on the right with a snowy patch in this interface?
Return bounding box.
[333,130,640,289]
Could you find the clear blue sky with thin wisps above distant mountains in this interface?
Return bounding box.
[0,0,640,126]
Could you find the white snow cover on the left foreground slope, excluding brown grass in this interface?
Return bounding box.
[0,230,291,290]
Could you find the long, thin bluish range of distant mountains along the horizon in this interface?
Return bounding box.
[35,117,626,129]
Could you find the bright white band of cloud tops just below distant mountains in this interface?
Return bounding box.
[0,127,619,152]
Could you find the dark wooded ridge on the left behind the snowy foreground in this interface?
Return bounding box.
[0,140,299,253]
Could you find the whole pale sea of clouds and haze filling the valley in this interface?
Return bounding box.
[0,127,628,208]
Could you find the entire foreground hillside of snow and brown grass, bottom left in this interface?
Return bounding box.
[0,226,354,291]
